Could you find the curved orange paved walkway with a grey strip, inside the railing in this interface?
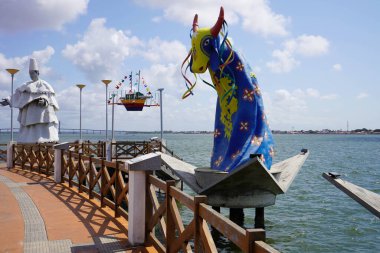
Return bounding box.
[0,163,155,253]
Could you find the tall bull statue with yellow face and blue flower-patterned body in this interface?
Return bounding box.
[182,7,274,172]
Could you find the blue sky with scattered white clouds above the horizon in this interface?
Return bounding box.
[0,0,380,131]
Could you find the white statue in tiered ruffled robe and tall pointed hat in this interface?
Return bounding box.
[1,59,59,143]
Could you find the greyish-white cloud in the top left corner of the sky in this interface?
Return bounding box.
[0,0,89,32]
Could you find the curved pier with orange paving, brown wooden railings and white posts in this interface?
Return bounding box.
[0,141,278,252]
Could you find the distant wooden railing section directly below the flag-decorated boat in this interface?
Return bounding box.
[111,141,162,161]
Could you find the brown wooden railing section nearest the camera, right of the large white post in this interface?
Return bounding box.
[146,175,278,252]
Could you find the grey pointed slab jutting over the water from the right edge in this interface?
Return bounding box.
[322,173,380,218]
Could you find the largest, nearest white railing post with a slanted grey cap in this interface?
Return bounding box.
[127,153,161,246]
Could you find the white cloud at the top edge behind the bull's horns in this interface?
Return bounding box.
[135,0,290,36]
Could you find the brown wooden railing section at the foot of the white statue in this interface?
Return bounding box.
[13,143,54,176]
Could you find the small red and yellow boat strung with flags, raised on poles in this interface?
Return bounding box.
[108,70,159,111]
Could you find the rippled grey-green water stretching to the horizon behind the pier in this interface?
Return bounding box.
[0,134,380,253]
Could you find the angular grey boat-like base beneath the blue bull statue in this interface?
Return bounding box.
[160,149,309,208]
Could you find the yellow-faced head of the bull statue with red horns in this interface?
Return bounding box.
[190,7,224,73]
